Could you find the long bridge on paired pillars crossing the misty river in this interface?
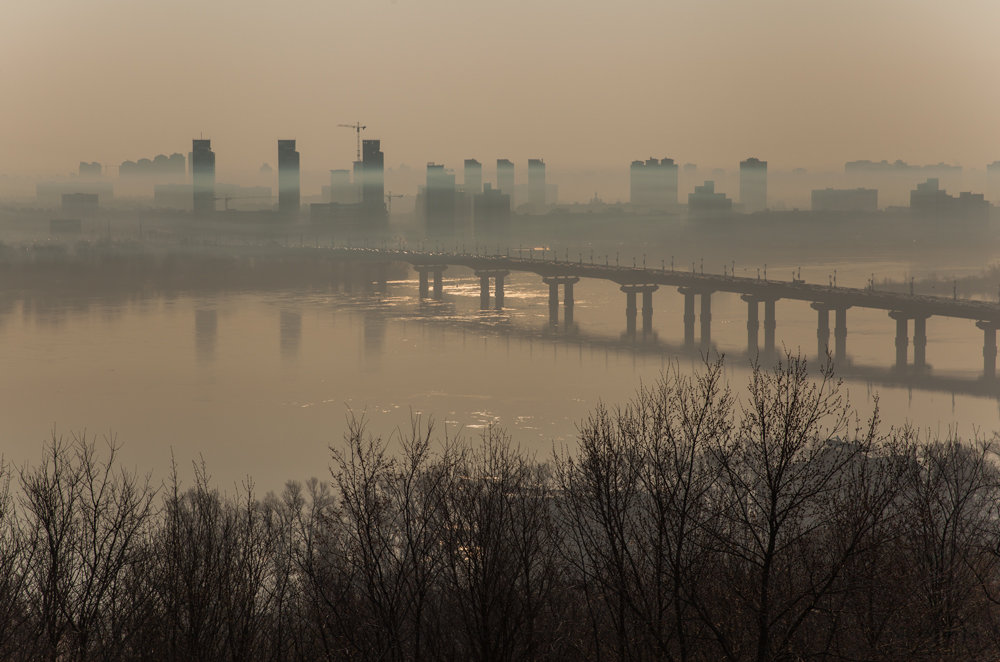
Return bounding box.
[324,248,1000,380]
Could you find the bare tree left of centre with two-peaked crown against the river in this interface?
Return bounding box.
[331,417,459,660]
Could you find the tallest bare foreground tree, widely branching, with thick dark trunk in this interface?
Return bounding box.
[698,355,901,662]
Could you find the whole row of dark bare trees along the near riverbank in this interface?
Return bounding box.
[0,357,1000,661]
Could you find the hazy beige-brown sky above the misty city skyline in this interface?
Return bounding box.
[0,0,1000,173]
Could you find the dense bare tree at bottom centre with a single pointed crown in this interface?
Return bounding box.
[440,426,558,661]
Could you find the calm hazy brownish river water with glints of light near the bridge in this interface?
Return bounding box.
[0,252,1000,491]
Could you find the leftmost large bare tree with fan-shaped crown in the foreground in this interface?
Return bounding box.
[21,435,154,660]
